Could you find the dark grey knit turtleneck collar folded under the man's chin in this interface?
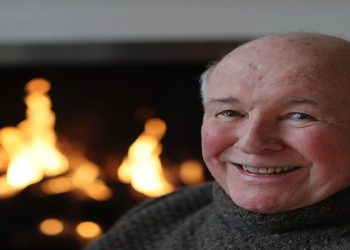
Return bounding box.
[213,182,350,232]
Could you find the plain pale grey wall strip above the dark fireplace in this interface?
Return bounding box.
[0,0,350,44]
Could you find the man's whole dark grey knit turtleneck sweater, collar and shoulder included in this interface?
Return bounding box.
[88,182,350,250]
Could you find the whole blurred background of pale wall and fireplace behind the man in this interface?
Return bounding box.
[0,0,350,250]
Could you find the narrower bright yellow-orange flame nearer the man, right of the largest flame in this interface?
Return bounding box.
[118,119,174,197]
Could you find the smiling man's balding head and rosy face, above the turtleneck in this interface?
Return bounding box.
[202,34,350,213]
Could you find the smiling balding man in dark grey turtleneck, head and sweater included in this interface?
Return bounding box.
[90,33,350,250]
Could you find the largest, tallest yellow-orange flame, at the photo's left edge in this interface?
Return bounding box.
[0,79,68,192]
